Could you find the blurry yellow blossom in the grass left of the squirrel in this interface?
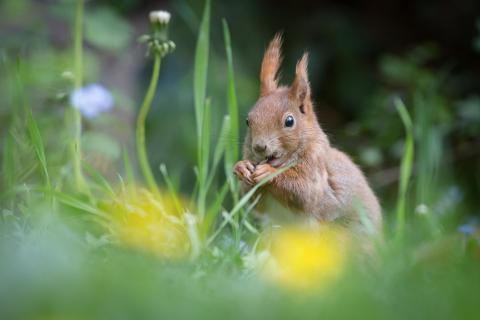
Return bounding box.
[106,188,190,258]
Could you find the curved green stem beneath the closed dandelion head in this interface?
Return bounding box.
[136,53,161,195]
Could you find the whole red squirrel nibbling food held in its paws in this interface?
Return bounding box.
[233,34,382,231]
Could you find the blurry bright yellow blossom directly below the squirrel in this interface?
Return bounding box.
[262,226,347,289]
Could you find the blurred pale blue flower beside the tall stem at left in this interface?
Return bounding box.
[70,83,114,119]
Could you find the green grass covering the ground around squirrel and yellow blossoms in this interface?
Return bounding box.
[0,0,480,319]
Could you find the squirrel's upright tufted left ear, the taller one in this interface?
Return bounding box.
[260,33,282,97]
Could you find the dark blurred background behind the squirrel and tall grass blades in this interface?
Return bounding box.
[0,0,480,214]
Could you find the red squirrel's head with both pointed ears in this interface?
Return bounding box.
[245,34,319,167]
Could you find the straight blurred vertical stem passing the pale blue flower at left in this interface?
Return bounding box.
[70,0,86,191]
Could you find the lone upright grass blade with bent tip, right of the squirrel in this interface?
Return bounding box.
[393,97,414,239]
